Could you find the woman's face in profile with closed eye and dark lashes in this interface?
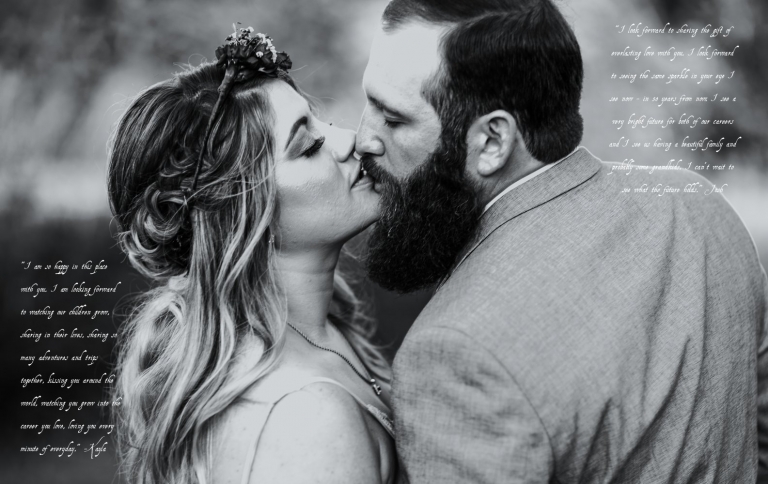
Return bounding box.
[266,81,379,250]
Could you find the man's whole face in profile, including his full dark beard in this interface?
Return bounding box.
[356,23,480,292]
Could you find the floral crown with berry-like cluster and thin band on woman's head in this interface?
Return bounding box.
[185,24,293,197]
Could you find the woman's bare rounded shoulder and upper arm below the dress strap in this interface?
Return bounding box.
[250,382,381,484]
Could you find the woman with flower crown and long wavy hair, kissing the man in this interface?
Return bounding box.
[109,28,396,483]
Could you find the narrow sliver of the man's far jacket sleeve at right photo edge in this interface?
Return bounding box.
[757,269,768,484]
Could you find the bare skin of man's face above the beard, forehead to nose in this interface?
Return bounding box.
[355,22,444,179]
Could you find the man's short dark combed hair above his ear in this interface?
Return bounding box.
[382,0,584,163]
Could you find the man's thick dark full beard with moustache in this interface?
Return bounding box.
[362,136,481,293]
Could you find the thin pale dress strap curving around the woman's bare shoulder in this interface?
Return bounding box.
[240,375,395,484]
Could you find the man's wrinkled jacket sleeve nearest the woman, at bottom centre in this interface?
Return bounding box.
[392,327,553,484]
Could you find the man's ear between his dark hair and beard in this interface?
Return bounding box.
[467,110,518,177]
